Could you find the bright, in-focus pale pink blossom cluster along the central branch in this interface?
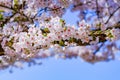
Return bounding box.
[2,17,92,54]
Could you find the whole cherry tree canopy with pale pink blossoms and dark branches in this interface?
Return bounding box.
[0,0,120,70]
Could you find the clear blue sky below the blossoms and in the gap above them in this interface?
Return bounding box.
[0,9,120,80]
